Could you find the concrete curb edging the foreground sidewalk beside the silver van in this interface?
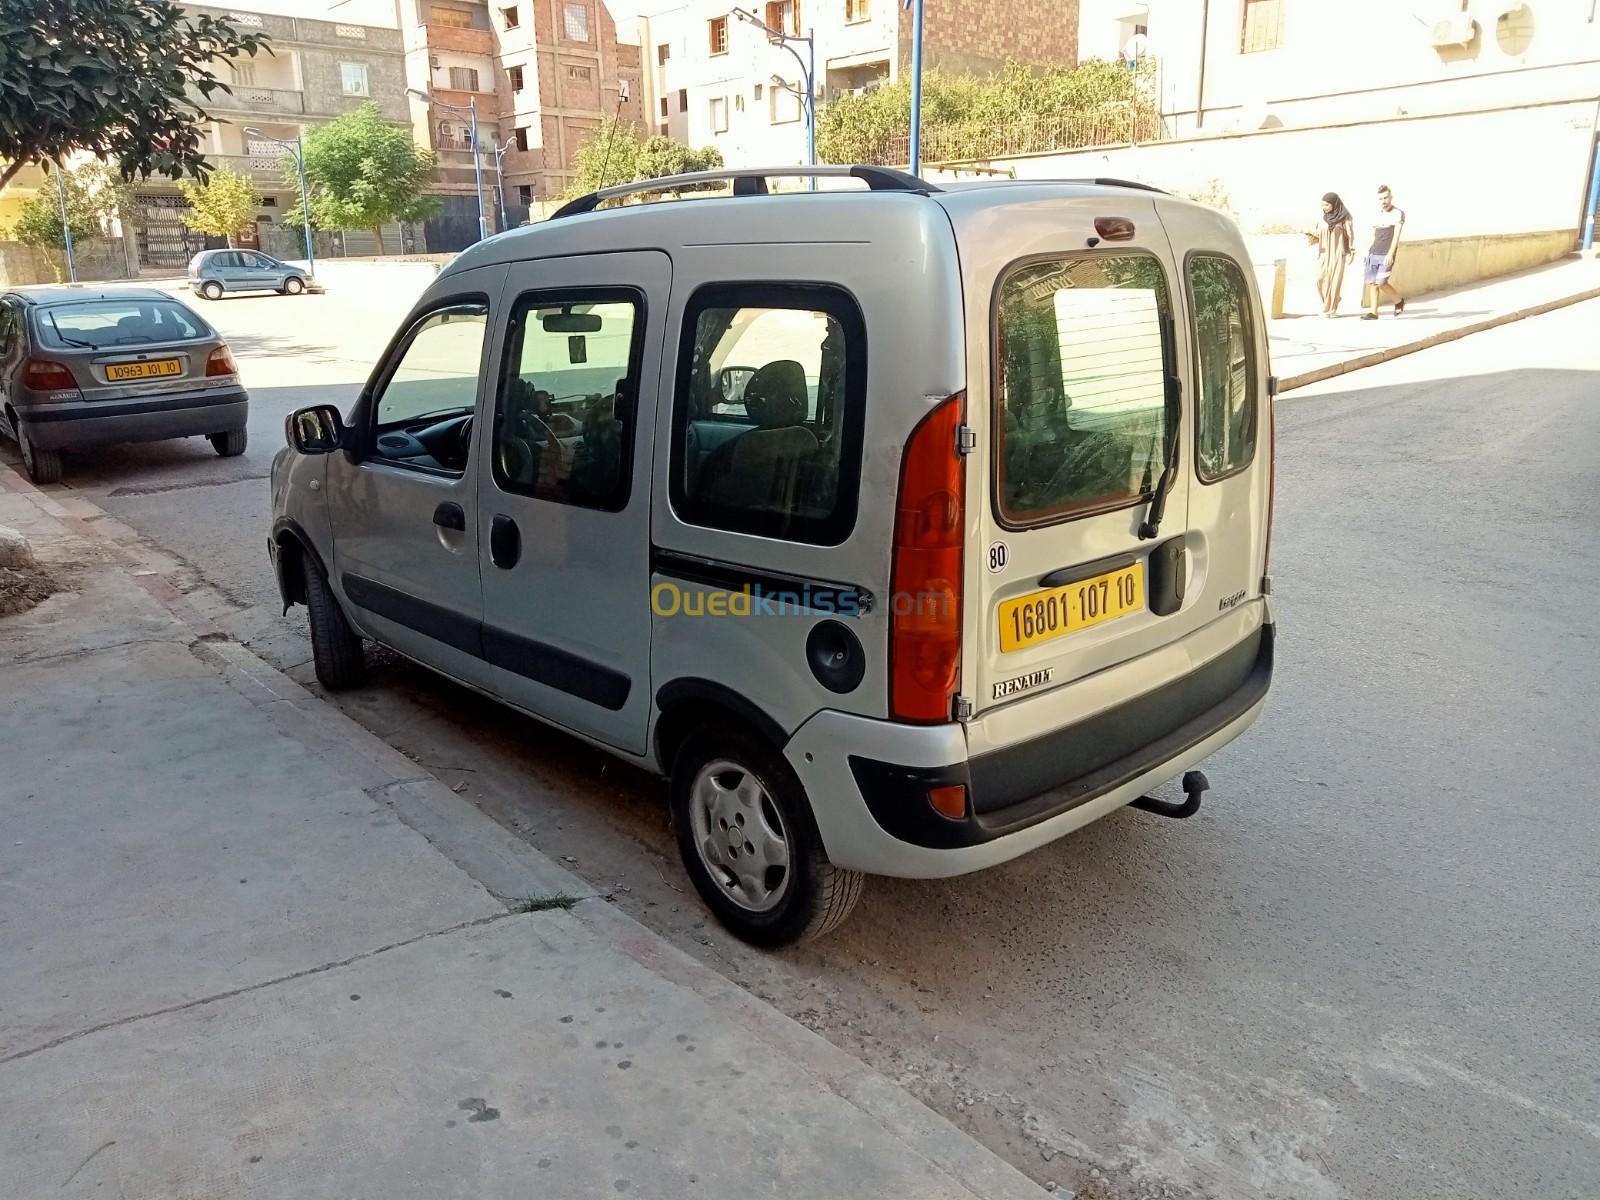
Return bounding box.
[0,464,1040,1200]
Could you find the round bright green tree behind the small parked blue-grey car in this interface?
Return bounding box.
[283,102,438,254]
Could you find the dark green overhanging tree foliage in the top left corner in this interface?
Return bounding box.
[0,0,270,189]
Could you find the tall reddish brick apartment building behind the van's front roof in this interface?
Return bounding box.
[400,0,642,225]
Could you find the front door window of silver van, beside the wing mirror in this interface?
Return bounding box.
[371,302,488,474]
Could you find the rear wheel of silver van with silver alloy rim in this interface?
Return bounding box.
[672,726,864,946]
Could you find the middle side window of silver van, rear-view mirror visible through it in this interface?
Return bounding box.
[494,290,645,512]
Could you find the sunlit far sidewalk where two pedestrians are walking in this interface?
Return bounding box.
[1267,258,1600,392]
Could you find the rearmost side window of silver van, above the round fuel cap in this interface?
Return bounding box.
[672,285,867,546]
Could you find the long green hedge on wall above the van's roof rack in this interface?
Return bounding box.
[816,61,1158,163]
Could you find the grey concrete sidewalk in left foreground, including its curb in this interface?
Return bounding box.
[0,467,1042,1200]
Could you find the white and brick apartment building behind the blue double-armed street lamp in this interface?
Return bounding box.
[638,0,1078,165]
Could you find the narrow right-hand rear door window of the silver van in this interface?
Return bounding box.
[1189,254,1259,483]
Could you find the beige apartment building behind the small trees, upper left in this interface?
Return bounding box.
[133,5,408,267]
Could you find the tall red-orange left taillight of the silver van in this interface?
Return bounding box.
[890,394,966,723]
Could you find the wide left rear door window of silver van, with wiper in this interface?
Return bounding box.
[995,254,1173,525]
